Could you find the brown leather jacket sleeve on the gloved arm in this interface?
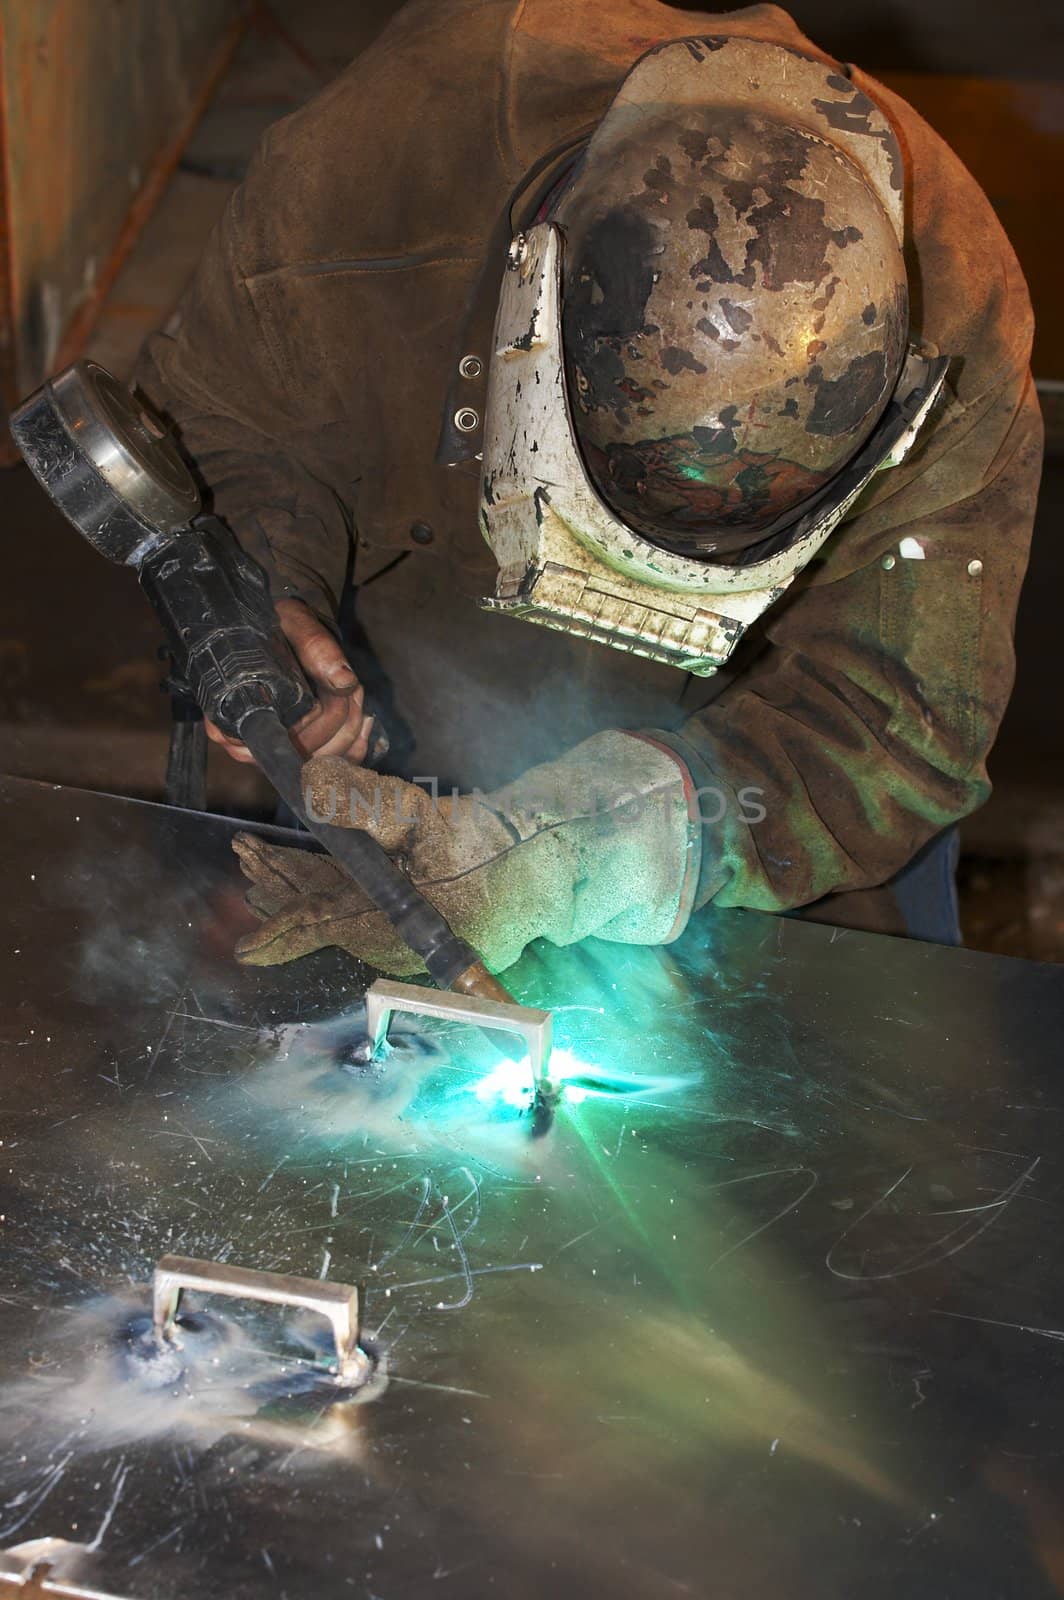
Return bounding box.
[664,366,1042,910]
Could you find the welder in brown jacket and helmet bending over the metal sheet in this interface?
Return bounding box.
[138,0,1040,976]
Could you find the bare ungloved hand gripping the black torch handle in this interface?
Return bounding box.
[206,600,373,765]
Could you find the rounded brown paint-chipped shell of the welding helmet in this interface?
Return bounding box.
[550,40,909,562]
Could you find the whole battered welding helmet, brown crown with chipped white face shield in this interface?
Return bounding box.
[480,38,947,675]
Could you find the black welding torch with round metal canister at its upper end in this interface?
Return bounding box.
[10,360,539,1068]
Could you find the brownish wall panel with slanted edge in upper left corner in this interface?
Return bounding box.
[0,0,248,422]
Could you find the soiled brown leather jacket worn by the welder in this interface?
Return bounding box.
[138,0,1042,931]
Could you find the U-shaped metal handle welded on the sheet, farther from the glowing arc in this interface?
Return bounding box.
[152,1256,368,1379]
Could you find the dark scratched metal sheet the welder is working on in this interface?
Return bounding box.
[0,768,1064,1600]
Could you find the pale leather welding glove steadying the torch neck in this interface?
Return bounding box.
[234,733,699,978]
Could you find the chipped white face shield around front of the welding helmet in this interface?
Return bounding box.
[480,222,947,677]
